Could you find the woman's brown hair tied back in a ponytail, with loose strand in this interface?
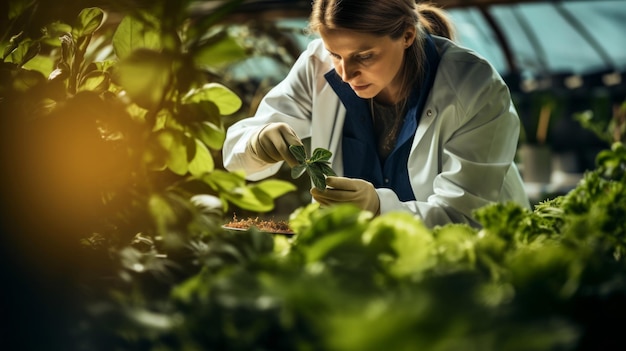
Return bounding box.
[309,0,454,103]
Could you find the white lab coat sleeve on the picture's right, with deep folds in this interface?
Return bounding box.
[377,53,523,227]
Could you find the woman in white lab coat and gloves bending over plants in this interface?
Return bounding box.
[223,0,529,227]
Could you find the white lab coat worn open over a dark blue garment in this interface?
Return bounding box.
[223,36,530,227]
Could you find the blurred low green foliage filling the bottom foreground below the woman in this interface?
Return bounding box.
[83,143,626,351]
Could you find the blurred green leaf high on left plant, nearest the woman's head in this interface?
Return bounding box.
[193,35,248,69]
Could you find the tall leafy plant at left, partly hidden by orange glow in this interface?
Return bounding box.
[2,1,294,246]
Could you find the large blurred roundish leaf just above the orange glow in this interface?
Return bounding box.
[115,49,172,109]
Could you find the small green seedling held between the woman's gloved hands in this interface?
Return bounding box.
[289,145,336,190]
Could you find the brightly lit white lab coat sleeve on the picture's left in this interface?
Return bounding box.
[222,42,319,180]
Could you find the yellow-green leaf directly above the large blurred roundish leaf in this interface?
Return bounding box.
[113,16,162,59]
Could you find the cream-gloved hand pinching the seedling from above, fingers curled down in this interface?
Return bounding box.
[247,122,302,167]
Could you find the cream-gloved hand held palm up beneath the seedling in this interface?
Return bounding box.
[311,176,380,215]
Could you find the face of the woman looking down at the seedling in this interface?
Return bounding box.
[320,29,415,103]
